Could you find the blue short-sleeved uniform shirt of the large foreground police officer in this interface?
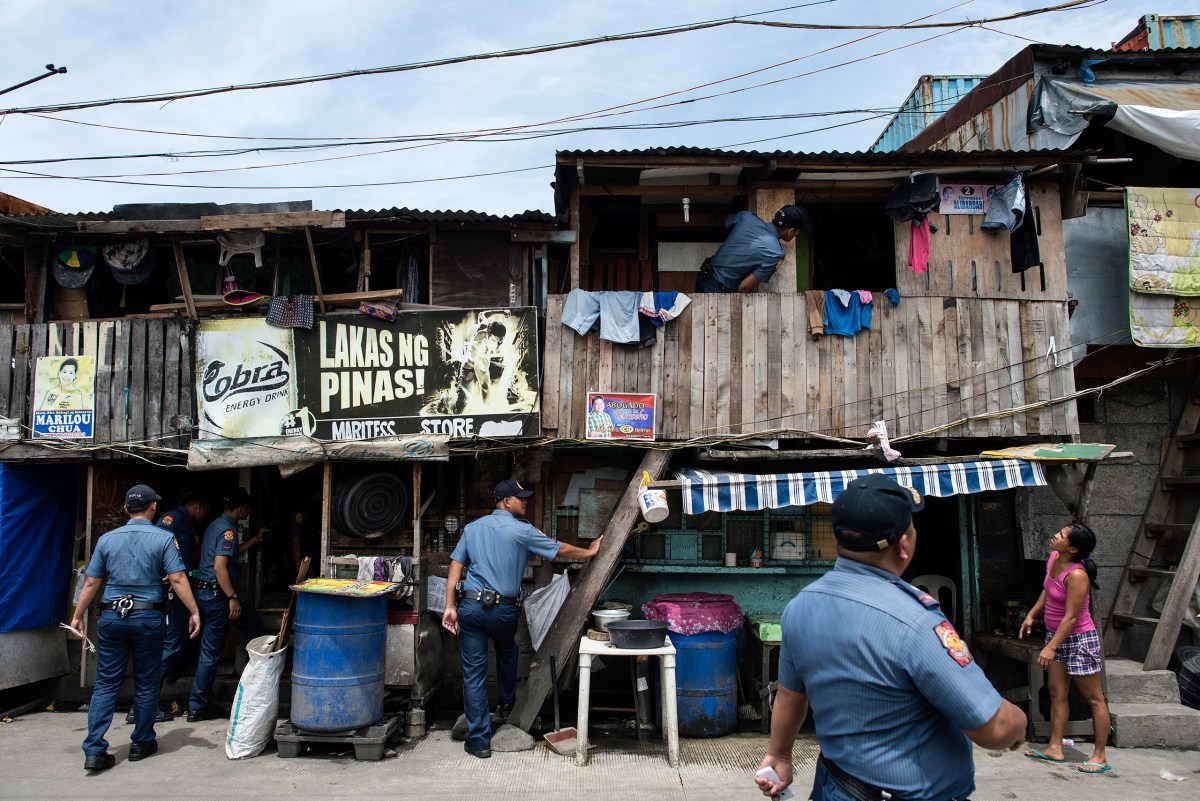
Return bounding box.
[779,559,1001,799]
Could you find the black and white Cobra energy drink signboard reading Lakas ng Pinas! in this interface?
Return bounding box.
[197,307,541,441]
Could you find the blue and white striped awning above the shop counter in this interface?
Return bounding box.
[679,459,1046,514]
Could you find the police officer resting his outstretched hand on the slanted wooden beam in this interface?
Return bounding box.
[442,478,604,759]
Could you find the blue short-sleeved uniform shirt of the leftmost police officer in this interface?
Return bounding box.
[85,518,185,603]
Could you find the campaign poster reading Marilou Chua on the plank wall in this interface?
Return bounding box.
[31,356,96,439]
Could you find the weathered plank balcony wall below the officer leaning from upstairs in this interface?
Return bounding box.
[542,293,1079,440]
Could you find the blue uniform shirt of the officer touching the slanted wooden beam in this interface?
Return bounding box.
[450,508,559,597]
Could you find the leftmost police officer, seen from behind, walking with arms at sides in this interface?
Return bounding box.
[71,484,200,771]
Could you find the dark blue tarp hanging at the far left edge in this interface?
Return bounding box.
[0,464,77,632]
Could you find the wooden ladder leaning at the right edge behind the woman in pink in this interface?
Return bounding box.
[1104,371,1200,670]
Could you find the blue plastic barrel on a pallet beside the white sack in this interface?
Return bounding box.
[292,591,388,731]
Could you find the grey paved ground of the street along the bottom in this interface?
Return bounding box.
[0,712,1200,801]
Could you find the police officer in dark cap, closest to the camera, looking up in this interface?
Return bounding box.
[756,474,1025,801]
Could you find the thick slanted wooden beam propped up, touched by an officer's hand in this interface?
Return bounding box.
[509,451,671,731]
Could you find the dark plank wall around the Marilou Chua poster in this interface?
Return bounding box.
[0,318,189,459]
